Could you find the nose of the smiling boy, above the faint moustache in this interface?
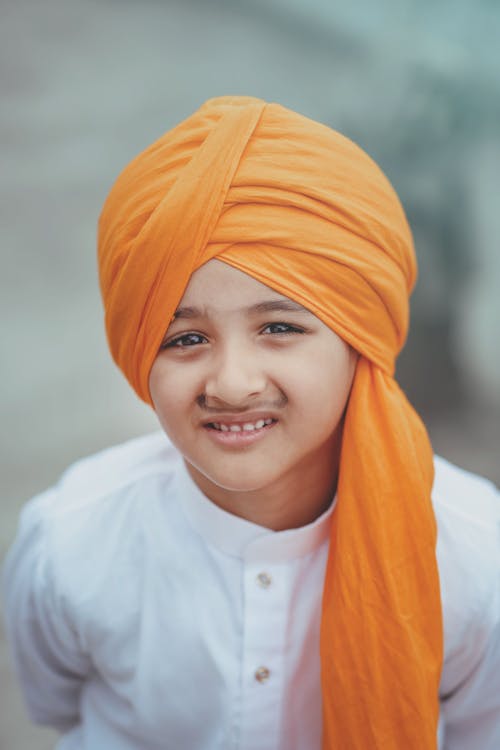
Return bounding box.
[205,349,267,406]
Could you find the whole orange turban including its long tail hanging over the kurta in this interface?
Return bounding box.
[99,97,443,750]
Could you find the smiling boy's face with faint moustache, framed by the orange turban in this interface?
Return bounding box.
[149,260,357,516]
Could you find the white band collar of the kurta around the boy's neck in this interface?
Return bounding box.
[176,461,336,563]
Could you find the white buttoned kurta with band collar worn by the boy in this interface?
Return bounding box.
[0,434,500,750]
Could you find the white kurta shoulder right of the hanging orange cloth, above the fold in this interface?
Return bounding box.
[432,457,500,692]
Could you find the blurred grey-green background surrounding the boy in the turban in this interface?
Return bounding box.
[0,0,500,750]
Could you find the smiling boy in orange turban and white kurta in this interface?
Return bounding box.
[5,97,500,750]
